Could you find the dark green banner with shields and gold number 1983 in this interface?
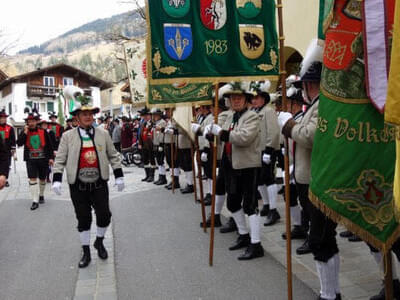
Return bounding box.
[147,0,279,85]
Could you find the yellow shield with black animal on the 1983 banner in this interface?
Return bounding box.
[239,24,265,59]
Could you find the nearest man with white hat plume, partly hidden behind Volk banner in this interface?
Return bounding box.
[278,40,340,300]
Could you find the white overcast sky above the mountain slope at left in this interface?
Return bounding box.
[0,0,144,54]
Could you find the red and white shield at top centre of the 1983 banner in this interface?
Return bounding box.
[200,0,227,30]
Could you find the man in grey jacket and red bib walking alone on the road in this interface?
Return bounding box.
[52,93,124,268]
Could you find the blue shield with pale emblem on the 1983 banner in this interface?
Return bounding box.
[164,24,193,60]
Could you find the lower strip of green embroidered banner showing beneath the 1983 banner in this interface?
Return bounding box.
[148,83,213,107]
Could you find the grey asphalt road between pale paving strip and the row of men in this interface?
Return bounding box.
[112,188,316,300]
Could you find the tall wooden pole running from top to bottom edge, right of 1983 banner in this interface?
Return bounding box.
[277,0,293,300]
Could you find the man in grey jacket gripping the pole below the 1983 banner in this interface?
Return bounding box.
[208,82,264,260]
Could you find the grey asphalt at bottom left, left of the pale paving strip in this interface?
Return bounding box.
[0,199,80,300]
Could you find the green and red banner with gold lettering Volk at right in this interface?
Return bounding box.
[310,0,399,251]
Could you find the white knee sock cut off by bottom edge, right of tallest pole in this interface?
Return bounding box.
[315,257,336,300]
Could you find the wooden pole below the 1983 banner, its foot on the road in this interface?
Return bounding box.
[209,82,218,266]
